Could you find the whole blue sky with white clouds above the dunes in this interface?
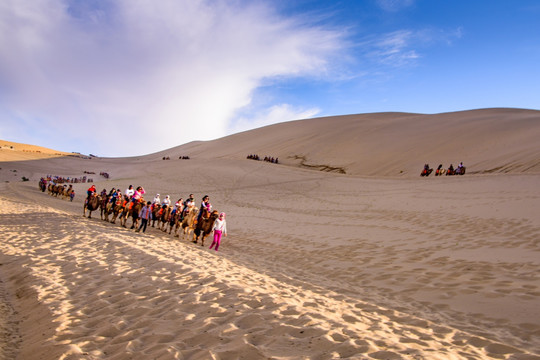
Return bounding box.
[0,0,540,157]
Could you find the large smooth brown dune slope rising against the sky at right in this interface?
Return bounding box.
[160,109,540,177]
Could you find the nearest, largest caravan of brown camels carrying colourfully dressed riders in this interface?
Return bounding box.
[78,185,219,246]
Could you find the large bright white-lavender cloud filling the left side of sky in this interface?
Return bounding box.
[0,0,343,156]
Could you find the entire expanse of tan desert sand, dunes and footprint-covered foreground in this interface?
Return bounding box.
[0,109,540,360]
